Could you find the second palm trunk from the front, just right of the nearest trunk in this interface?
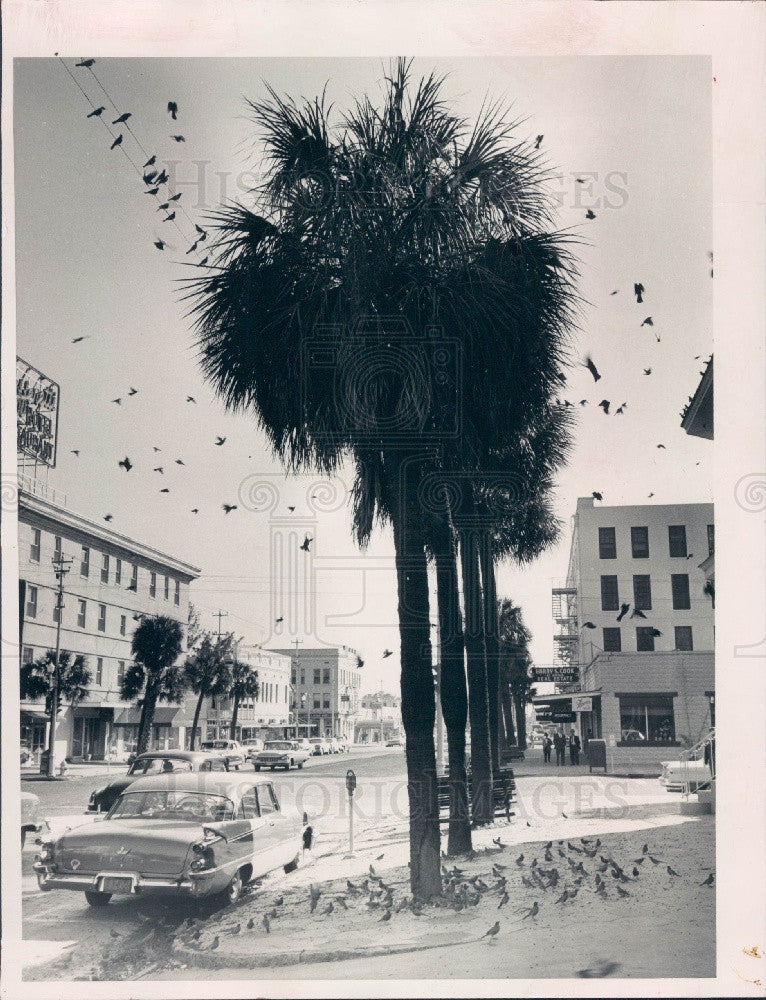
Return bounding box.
[432,517,472,855]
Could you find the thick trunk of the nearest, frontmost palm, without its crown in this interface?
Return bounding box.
[390,456,442,900]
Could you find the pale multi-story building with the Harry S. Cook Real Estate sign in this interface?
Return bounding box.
[535,498,715,773]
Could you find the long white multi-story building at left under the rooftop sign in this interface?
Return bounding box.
[19,477,200,761]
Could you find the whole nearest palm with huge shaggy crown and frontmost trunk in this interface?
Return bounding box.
[190,60,572,898]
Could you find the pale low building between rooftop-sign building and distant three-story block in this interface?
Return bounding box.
[202,645,292,740]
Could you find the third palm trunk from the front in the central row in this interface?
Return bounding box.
[460,529,493,826]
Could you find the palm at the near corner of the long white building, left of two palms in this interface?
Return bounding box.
[121,615,186,753]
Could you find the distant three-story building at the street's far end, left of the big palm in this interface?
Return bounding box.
[275,646,362,742]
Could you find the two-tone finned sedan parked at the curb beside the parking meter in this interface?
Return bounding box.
[34,772,313,906]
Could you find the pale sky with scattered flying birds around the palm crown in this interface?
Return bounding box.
[14,57,713,691]
